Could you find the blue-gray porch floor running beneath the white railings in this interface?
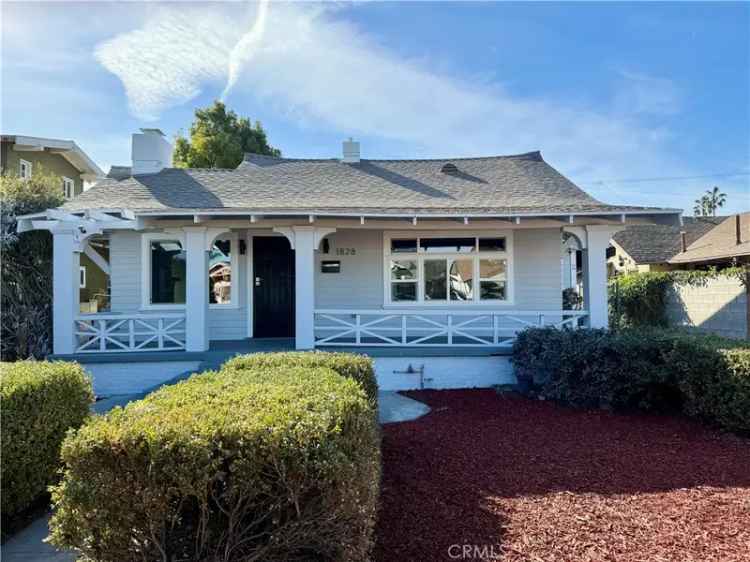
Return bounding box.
[50,338,511,369]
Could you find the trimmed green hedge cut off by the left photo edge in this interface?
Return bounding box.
[0,361,94,516]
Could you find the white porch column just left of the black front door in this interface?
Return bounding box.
[183,226,208,351]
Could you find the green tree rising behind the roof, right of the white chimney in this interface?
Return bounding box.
[173,101,281,168]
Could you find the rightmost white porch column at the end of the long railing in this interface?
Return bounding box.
[583,226,620,328]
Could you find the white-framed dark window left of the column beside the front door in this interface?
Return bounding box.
[141,233,187,309]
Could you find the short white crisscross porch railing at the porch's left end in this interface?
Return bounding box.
[74,314,185,353]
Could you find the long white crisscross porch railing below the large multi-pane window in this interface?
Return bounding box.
[315,310,588,347]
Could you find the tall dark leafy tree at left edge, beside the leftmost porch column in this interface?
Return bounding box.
[0,166,64,361]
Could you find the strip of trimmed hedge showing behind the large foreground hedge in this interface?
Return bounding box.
[222,351,378,404]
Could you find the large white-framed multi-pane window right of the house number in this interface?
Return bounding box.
[383,231,514,306]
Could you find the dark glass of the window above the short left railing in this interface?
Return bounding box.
[150,240,186,305]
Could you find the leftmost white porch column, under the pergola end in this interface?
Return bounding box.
[52,229,81,354]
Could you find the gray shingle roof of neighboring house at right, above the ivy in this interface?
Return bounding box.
[612,217,724,264]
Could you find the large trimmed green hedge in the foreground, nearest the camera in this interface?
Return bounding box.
[51,367,380,561]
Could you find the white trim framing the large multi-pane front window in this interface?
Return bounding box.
[383,230,515,309]
